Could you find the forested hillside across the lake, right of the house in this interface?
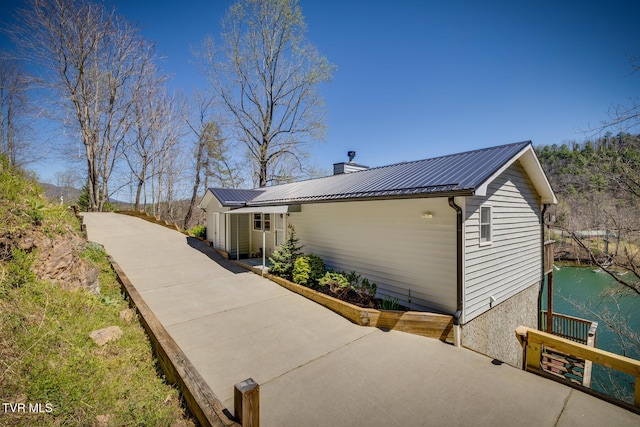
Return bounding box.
[536,133,640,293]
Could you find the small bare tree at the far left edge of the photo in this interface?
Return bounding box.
[0,53,33,166]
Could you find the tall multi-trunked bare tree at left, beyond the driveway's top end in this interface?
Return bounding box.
[14,0,154,210]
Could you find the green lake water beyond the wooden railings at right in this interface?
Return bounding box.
[543,266,640,403]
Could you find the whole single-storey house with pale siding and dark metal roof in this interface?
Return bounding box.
[200,141,557,366]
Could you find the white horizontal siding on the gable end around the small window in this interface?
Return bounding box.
[464,162,541,322]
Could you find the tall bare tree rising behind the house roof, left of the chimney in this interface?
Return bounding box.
[202,0,334,187]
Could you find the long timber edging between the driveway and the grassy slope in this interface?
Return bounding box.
[107,255,240,427]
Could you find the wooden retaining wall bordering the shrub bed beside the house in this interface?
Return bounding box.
[236,262,453,343]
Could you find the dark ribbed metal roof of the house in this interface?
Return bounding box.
[206,141,550,206]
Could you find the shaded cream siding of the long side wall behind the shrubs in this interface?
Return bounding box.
[288,198,456,313]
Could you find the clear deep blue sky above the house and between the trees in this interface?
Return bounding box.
[2,0,640,181]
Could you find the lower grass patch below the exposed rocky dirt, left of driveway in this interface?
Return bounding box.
[0,242,193,426]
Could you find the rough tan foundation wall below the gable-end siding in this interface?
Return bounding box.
[462,283,539,368]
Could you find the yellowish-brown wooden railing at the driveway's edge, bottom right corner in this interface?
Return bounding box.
[516,326,640,410]
